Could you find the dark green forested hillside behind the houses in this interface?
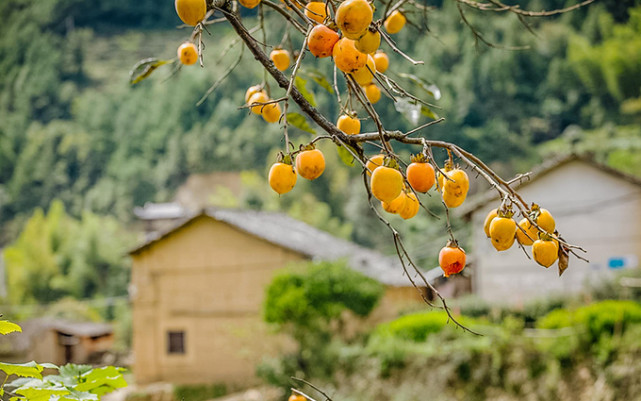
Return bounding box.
[0,0,641,247]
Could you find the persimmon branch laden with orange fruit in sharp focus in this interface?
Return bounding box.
[131,0,593,331]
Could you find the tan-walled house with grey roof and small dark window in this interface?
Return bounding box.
[131,205,424,384]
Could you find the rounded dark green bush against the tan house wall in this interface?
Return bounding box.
[257,262,383,388]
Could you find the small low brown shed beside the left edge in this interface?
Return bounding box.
[0,318,114,365]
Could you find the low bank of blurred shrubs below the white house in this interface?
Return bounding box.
[284,303,641,401]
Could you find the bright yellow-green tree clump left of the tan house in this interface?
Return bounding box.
[5,202,130,303]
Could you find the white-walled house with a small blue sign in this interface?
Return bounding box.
[462,155,641,306]
